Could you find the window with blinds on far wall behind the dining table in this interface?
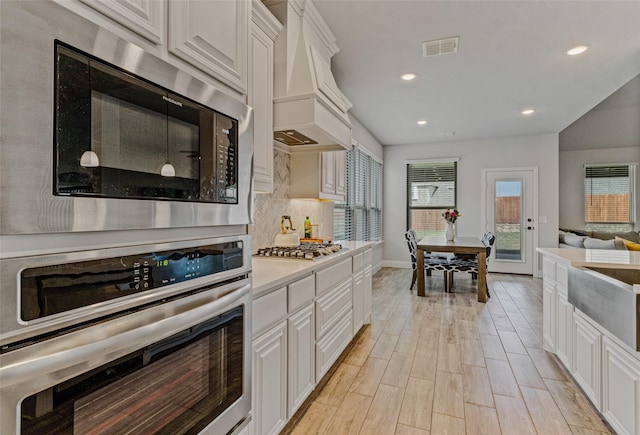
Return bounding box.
[407,161,458,238]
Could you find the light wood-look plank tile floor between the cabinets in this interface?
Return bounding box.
[287,268,613,435]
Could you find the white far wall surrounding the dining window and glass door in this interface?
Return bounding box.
[383,134,559,266]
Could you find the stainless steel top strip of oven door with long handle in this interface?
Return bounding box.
[0,279,251,396]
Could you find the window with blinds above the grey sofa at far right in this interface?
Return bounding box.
[584,164,635,231]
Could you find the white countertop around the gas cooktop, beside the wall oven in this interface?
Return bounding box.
[251,241,375,298]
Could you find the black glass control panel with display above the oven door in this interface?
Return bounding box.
[20,241,243,321]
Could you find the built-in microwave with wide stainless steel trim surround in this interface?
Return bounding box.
[0,7,253,235]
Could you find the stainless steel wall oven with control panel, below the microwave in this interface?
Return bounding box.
[0,236,251,434]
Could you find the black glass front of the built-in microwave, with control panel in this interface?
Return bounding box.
[54,43,238,203]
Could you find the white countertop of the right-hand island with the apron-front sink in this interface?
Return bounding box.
[537,248,640,269]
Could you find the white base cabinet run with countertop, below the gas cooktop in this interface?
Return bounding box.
[250,242,373,434]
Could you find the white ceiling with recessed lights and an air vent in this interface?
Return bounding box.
[314,0,640,145]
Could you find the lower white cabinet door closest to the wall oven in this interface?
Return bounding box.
[253,321,287,435]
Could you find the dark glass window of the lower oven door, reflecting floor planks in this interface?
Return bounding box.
[21,306,244,435]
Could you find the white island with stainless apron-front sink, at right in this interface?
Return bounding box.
[538,248,640,434]
